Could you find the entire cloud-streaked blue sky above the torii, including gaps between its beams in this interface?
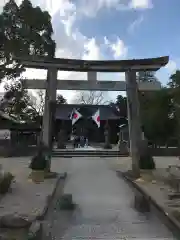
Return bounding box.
[1,0,180,102]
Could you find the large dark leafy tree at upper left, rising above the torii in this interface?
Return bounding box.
[0,0,55,80]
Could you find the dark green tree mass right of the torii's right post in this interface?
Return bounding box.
[139,88,174,145]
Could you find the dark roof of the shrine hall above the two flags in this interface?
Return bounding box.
[55,104,121,120]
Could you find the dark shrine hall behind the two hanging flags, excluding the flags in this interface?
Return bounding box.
[54,104,127,143]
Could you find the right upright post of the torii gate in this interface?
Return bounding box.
[125,70,142,177]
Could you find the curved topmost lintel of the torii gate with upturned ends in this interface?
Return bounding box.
[14,56,169,72]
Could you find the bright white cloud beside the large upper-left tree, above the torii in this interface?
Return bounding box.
[0,0,127,100]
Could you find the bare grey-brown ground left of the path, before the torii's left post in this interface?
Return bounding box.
[0,158,64,226]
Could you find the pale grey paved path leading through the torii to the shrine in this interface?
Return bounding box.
[43,158,174,240]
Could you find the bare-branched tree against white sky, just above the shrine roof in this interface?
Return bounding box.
[73,91,109,105]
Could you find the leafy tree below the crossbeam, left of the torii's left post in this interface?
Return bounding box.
[3,83,67,121]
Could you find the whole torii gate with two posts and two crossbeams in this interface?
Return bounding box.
[15,56,169,176]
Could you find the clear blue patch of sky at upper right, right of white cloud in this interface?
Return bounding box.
[74,0,180,84]
